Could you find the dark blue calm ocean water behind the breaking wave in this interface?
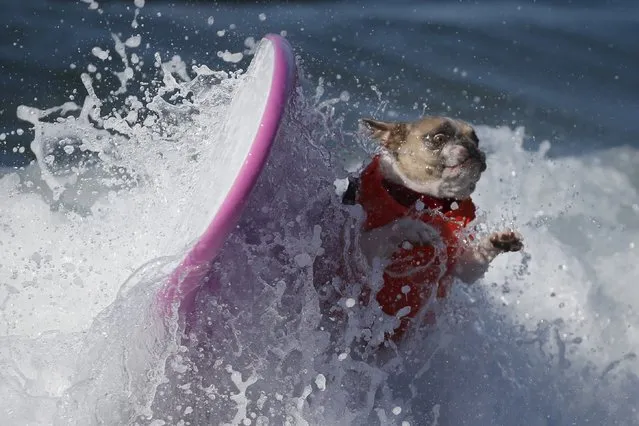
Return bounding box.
[0,0,639,165]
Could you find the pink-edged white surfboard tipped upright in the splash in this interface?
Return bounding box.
[158,34,296,315]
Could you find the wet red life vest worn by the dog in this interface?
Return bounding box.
[357,156,475,334]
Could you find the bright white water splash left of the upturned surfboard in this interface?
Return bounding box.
[0,13,249,424]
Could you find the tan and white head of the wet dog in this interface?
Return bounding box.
[362,117,486,200]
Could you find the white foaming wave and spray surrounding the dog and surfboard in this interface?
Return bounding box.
[0,2,639,425]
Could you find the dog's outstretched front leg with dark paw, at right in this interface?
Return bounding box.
[455,231,524,284]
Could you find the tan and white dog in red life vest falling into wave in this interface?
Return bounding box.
[342,116,523,340]
